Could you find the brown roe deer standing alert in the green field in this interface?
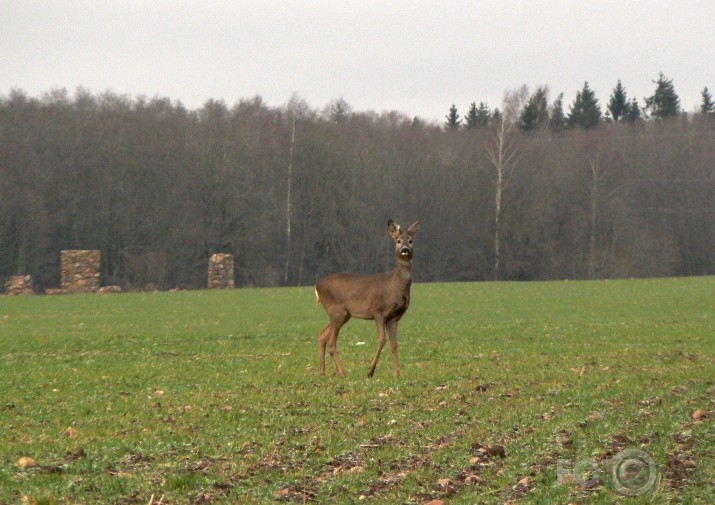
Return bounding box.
[315,219,419,377]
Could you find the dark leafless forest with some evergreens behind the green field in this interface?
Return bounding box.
[0,79,715,290]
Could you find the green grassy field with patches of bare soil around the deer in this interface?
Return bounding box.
[0,277,715,504]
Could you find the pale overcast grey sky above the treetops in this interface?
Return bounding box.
[0,0,715,122]
